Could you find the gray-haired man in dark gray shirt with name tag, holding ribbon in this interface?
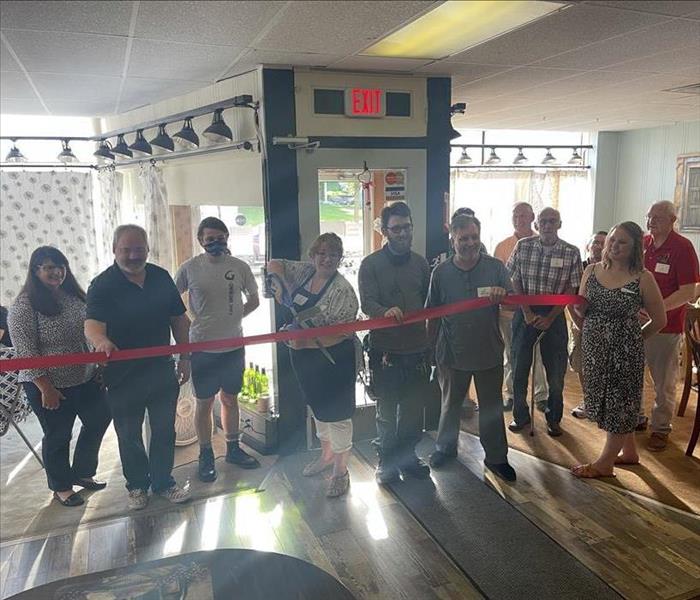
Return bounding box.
[426,215,515,481]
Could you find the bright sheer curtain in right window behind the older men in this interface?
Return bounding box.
[450,169,593,252]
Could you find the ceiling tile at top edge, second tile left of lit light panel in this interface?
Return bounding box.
[135,1,286,48]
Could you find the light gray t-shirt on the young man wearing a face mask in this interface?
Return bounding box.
[175,254,258,352]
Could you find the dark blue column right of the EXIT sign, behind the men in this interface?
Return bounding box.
[425,77,452,264]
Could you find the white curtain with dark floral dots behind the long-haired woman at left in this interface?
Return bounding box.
[0,171,97,306]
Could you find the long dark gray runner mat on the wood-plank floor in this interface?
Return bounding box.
[356,436,620,600]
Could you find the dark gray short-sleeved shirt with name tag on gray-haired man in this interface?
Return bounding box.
[426,254,512,371]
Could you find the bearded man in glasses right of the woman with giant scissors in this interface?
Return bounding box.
[359,202,430,484]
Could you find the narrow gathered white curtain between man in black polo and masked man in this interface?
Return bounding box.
[139,163,174,273]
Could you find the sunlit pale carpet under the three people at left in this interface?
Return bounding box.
[0,419,276,542]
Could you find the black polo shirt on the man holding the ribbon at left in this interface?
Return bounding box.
[87,263,186,385]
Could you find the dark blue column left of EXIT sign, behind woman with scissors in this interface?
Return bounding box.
[263,69,306,454]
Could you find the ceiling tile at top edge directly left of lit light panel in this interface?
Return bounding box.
[255,0,435,54]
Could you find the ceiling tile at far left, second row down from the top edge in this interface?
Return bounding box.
[4,29,126,75]
